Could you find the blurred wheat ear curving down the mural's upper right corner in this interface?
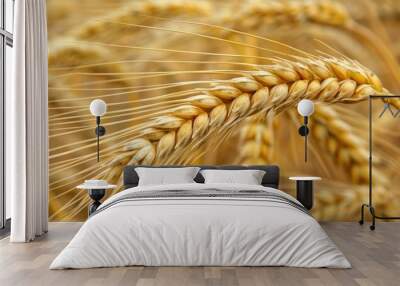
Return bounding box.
[222,0,400,87]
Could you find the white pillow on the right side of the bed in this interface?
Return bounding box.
[200,169,265,185]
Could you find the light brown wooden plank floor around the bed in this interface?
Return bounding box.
[0,222,400,286]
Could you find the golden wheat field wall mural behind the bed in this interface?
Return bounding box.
[47,0,400,221]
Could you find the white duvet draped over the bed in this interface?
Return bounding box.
[50,184,351,269]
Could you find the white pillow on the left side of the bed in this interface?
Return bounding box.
[135,167,200,186]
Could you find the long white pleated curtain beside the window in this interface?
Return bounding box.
[6,0,48,242]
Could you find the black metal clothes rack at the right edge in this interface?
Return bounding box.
[359,95,400,230]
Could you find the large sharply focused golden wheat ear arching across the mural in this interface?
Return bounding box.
[101,56,386,184]
